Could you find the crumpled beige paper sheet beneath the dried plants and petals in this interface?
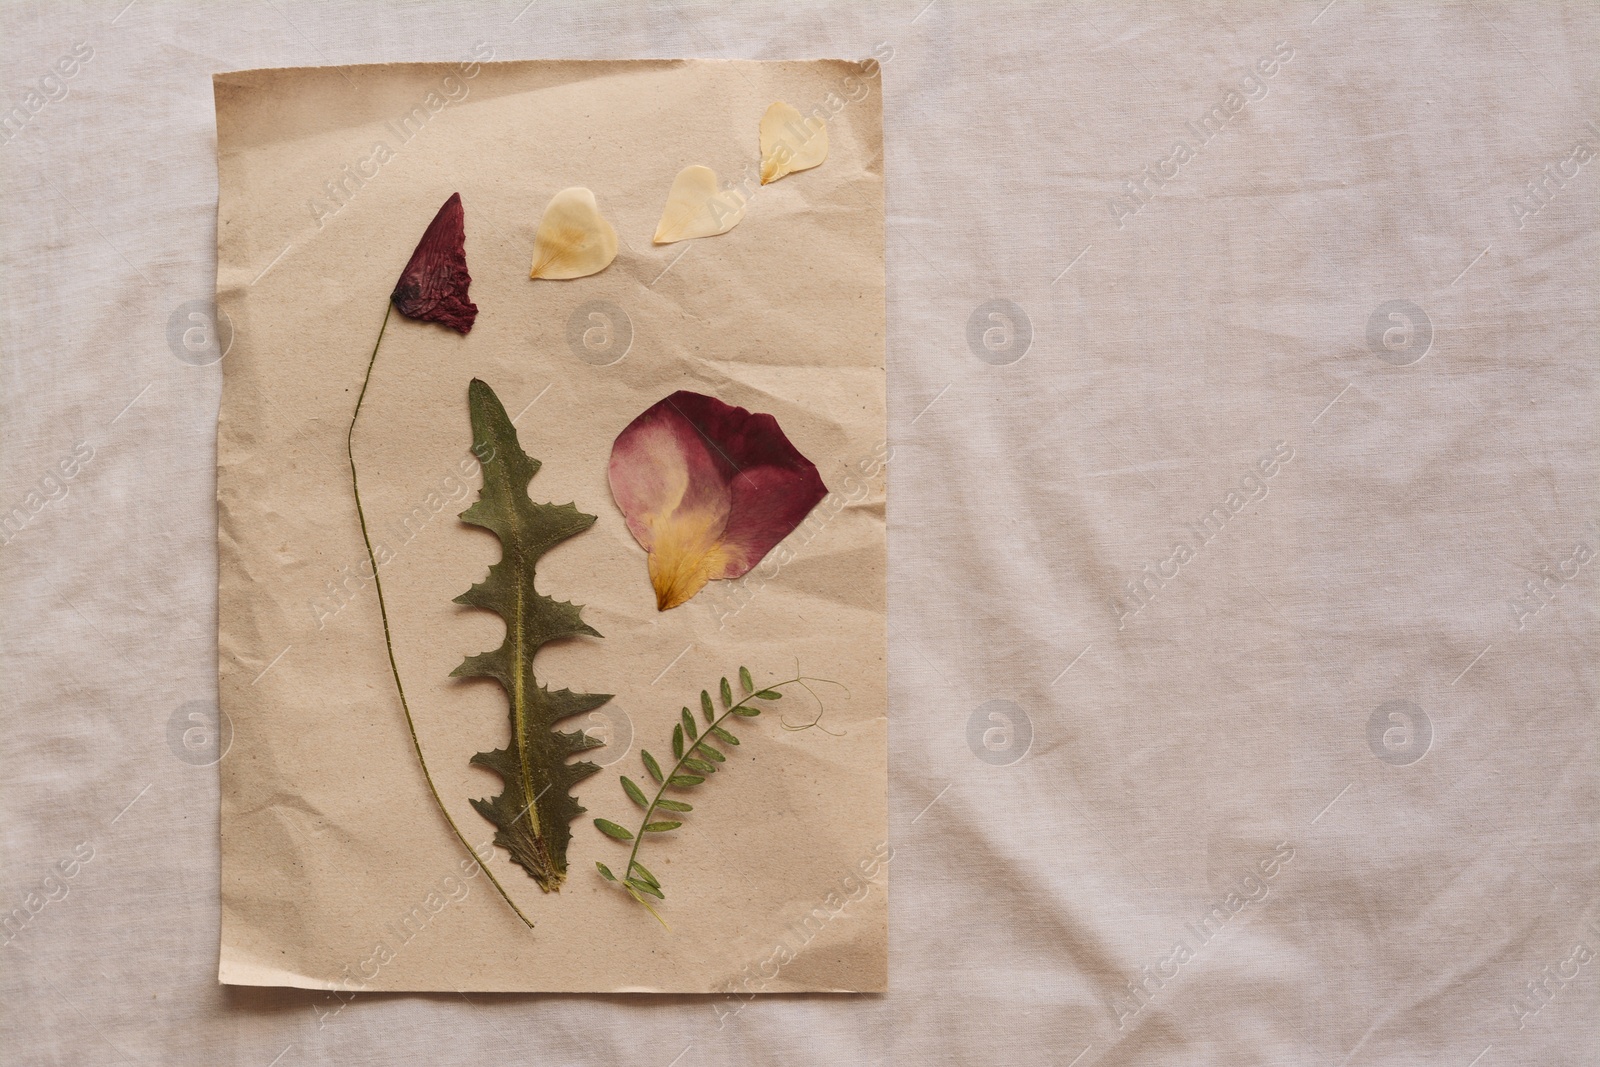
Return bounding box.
[216,61,886,992]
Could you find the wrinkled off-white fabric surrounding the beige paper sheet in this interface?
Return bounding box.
[0,0,1600,1067]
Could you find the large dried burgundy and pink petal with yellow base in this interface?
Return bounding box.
[610,390,827,611]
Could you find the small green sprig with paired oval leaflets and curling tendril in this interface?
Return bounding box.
[595,667,824,926]
